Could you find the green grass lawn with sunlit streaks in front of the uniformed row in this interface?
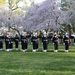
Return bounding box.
[0,44,75,75]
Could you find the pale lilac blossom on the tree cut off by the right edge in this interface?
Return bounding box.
[65,0,75,26]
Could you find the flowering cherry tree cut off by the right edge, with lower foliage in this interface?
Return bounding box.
[64,0,75,31]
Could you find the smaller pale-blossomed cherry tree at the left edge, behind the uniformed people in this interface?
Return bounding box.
[0,12,23,31]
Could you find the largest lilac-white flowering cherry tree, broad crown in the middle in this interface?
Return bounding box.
[23,0,63,31]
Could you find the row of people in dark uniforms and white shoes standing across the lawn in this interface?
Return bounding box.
[0,31,75,52]
